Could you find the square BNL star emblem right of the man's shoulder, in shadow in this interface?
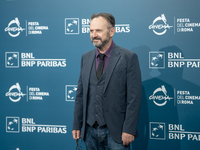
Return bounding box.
[149,52,165,69]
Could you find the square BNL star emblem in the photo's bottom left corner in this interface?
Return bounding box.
[6,117,19,133]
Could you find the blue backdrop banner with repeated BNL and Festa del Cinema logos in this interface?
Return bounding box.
[0,0,200,150]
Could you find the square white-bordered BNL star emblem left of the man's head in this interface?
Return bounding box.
[65,18,79,34]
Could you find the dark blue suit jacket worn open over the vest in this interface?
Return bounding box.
[73,45,142,143]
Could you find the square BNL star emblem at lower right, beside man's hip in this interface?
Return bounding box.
[149,122,166,140]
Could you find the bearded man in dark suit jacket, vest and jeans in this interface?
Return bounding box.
[72,13,142,150]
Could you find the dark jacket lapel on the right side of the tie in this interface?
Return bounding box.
[103,45,121,93]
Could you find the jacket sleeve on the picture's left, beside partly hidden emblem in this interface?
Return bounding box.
[73,56,83,130]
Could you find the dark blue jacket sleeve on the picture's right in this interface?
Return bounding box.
[123,53,142,136]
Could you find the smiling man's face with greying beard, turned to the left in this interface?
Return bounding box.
[90,17,111,49]
